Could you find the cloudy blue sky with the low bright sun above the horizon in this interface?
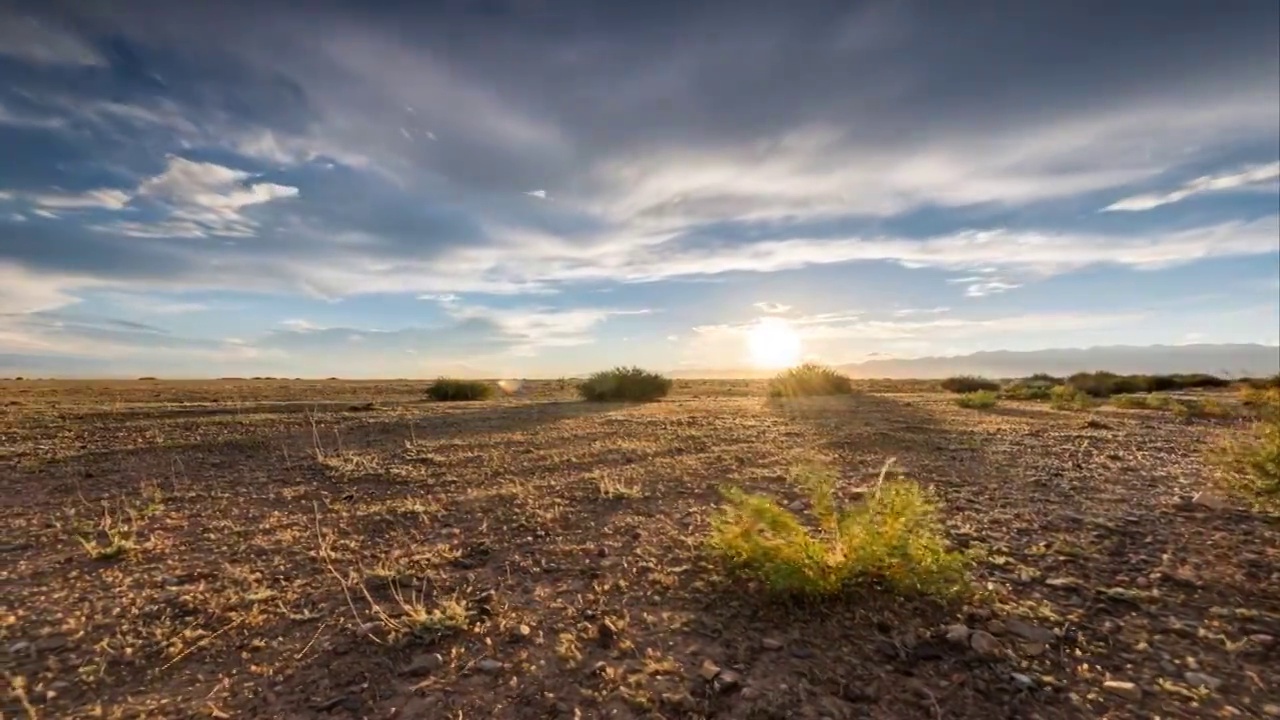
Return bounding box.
[0,0,1280,378]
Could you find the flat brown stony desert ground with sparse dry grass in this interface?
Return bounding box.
[0,380,1280,720]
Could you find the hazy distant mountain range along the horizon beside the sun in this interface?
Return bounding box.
[672,345,1280,379]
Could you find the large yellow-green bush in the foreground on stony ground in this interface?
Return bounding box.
[709,465,968,597]
